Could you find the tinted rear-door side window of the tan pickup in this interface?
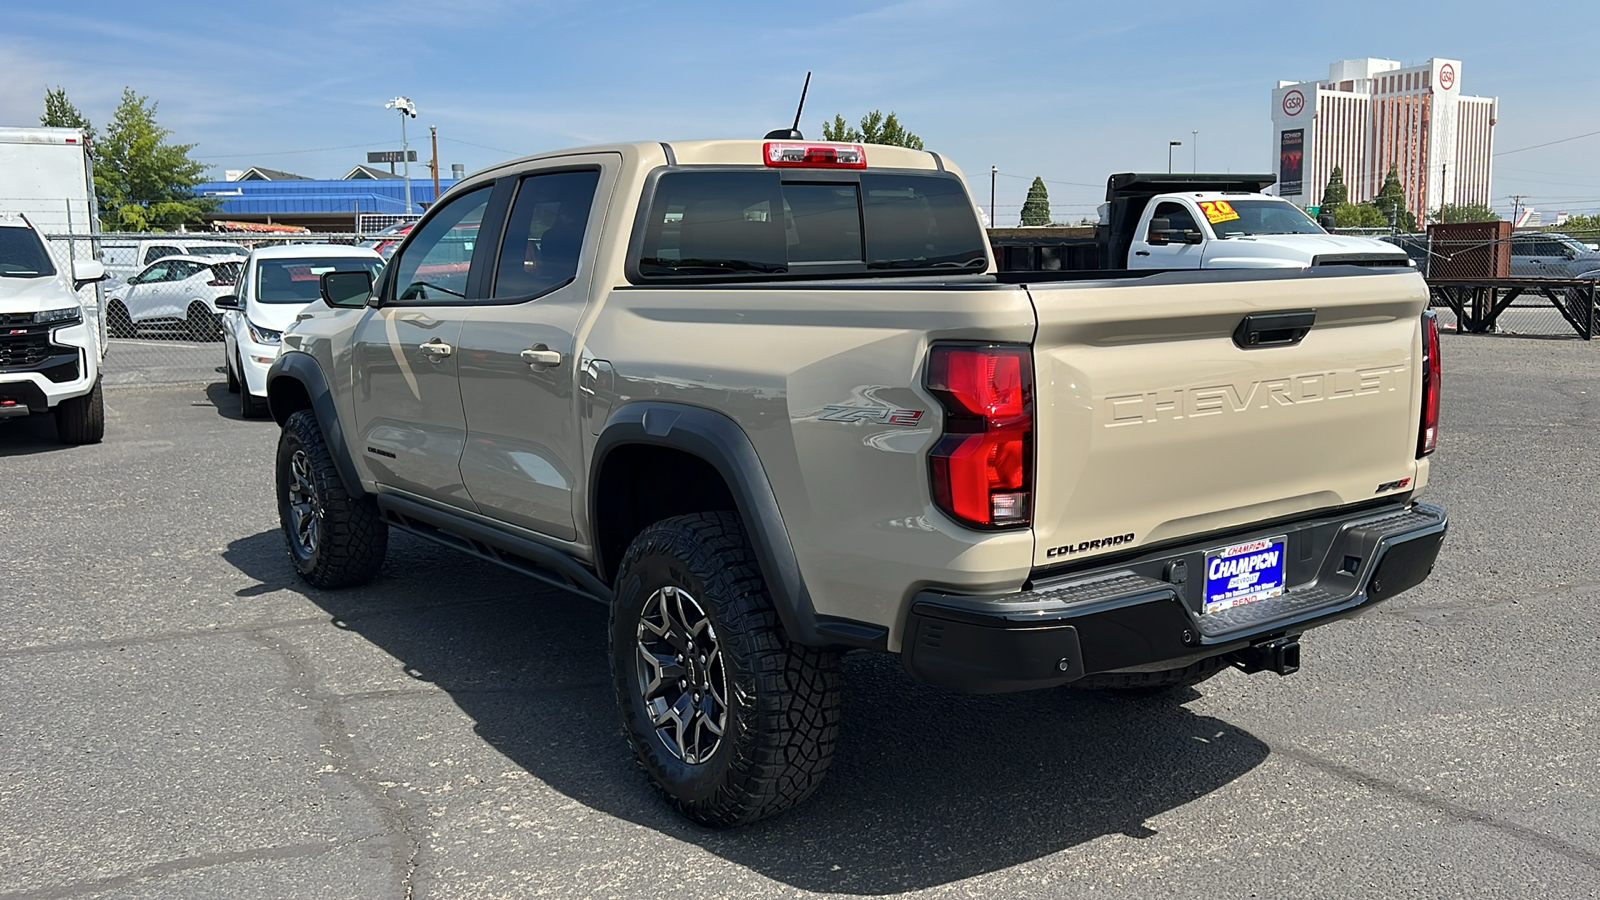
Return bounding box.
[490,170,600,298]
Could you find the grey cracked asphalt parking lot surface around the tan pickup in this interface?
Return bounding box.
[0,335,1600,900]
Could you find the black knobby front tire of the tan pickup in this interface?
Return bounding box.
[277,410,389,588]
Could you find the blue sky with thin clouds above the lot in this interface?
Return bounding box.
[0,0,1600,224]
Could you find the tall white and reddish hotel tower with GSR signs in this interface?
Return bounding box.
[1272,59,1499,223]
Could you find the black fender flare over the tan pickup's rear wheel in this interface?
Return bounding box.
[589,400,888,649]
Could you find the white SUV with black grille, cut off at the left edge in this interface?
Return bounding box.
[0,218,106,444]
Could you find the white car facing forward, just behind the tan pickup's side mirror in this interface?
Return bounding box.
[222,243,384,418]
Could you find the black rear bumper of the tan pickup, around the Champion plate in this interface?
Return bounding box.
[901,503,1448,693]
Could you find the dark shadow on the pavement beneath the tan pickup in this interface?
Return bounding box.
[224,532,1269,895]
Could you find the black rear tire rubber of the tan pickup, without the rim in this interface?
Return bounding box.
[610,512,842,828]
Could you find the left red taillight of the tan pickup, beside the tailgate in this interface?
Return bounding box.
[928,346,1034,527]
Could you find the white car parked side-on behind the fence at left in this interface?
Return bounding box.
[106,256,242,341]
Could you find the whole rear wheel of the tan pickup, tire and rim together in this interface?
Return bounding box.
[611,512,842,826]
